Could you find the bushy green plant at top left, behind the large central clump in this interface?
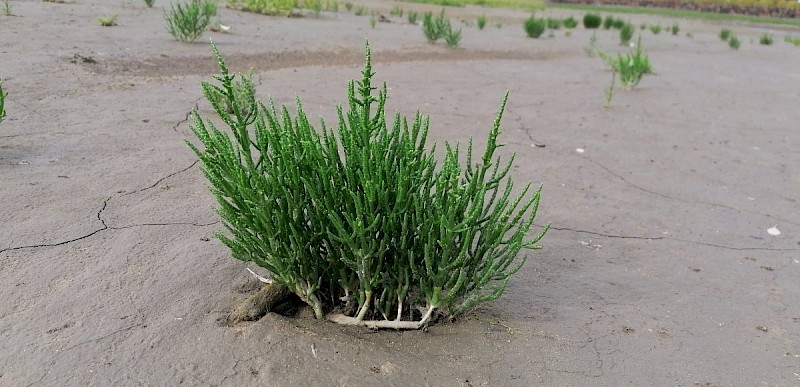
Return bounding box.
[164,0,217,42]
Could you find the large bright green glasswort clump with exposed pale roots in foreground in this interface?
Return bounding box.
[187,41,548,328]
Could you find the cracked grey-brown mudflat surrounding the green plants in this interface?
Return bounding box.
[0,0,800,386]
